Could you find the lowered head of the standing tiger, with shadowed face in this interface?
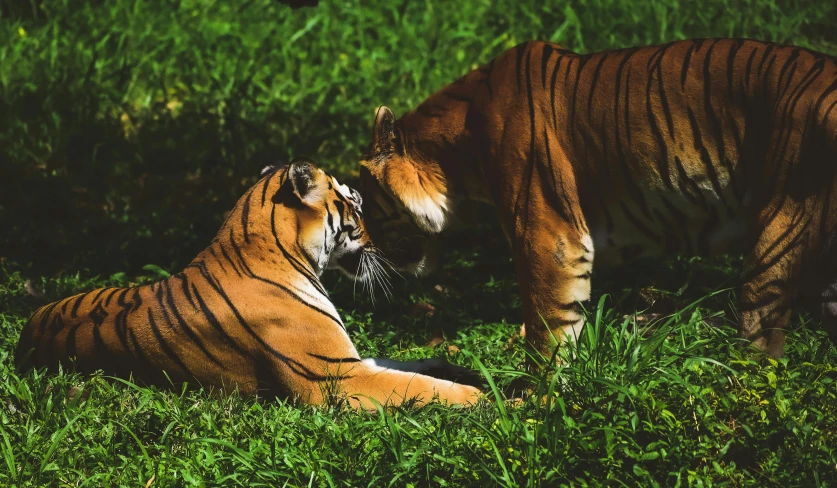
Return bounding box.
[360,107,450,275]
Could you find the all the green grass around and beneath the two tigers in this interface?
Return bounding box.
[0,0,837,487]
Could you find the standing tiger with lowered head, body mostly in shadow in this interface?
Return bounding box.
[361,39,837,362]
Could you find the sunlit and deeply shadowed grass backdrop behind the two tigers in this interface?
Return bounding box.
[0,0,837,273]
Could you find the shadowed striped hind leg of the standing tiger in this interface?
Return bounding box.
[739,211,807,357]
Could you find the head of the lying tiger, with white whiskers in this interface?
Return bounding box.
[257,158,382,281]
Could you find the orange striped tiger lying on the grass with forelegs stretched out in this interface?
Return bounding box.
[16,158,481,409]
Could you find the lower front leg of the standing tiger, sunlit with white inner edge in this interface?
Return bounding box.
[516,222,593,359]
